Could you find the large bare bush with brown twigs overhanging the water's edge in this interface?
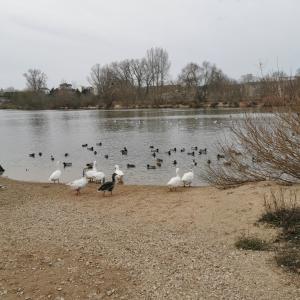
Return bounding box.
[203,110,300,188]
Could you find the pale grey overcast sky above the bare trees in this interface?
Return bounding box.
[0,0,300,89]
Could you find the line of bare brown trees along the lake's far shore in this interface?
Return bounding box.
[0,48,300,109]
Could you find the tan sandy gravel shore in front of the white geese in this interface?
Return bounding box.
[0,178,300,300]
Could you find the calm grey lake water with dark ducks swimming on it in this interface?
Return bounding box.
[0,109,251,185]
